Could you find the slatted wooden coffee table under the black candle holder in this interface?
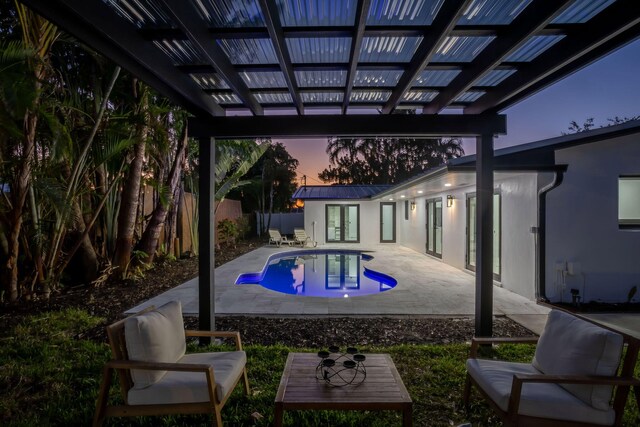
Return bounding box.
[274,353,413,427]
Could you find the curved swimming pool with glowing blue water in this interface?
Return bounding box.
[236,249,398,298]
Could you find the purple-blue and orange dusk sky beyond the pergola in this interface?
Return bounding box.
[280,40,640,185]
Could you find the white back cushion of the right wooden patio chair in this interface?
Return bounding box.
[532,310,623,410]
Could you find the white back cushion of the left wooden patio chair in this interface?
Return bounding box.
[124,301,186,389]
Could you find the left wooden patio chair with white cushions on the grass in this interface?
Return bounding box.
[93,301,249,427]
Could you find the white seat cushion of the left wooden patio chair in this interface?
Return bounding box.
[127,351,247,405]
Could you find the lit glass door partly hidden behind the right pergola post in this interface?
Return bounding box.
[466,193,502,281]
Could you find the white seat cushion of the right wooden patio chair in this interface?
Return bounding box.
[467,359,615,425]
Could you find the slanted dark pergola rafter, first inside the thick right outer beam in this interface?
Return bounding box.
[422,0,572,114]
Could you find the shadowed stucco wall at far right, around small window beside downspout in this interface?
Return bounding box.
[545,134,640,302]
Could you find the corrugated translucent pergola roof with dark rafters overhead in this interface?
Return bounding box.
[23,0,640,118]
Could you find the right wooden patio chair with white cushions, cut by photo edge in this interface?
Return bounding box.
[464,310,640,426]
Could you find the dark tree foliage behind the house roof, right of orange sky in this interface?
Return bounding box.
[318,137,464,184]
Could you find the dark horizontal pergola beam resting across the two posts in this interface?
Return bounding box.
[189,114,507,139]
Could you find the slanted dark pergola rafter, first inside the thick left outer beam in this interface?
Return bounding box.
[158,0,263,115]
